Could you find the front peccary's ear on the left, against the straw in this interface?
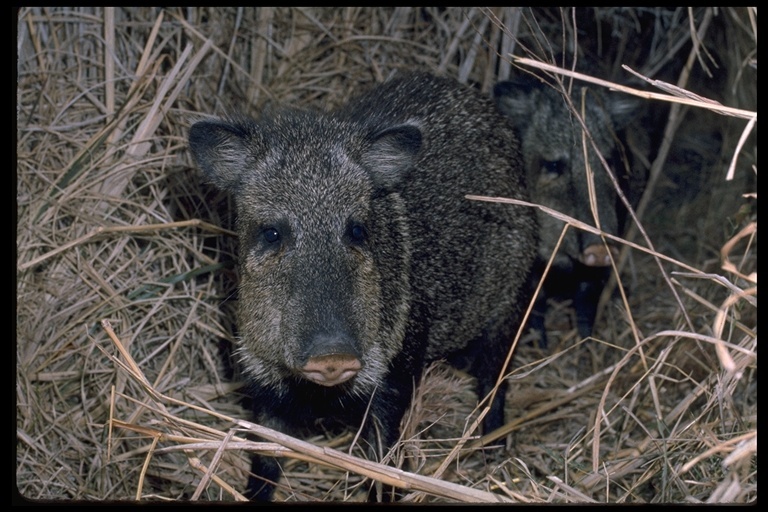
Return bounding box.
[189,120,254,190]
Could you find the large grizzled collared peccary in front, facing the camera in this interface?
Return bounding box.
[189,73,537,500]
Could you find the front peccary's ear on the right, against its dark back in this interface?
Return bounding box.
[362,122,422,188]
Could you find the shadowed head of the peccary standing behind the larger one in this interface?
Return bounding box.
[494,79,639,269]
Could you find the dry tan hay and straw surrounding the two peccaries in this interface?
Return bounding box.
[16,7,757,503]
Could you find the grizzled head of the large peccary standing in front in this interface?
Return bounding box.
[189,111,421,395]
